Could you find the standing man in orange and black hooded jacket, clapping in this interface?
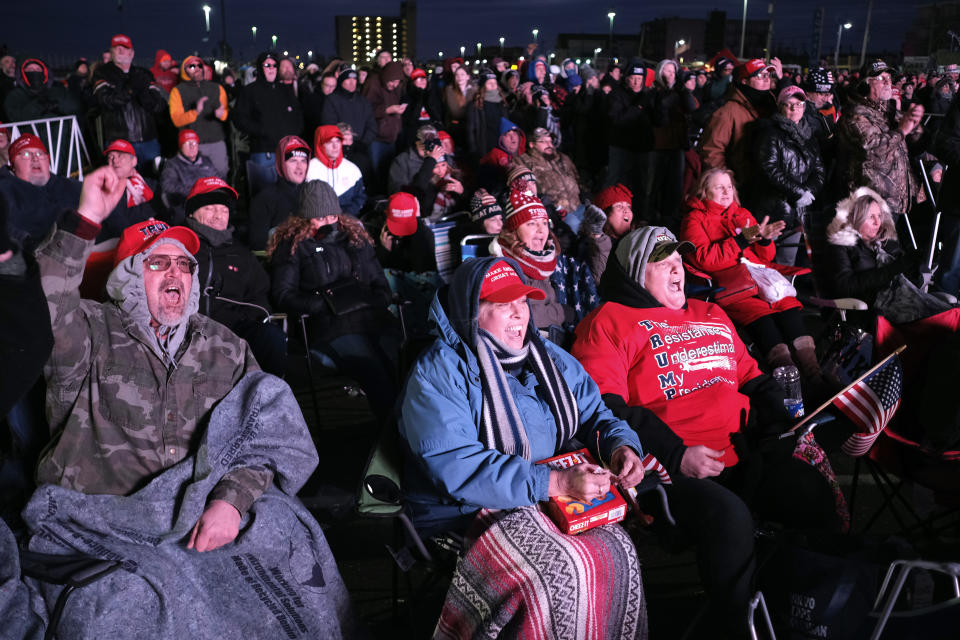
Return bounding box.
[170,56,230,178]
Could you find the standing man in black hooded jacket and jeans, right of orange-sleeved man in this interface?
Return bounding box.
[233,52,303,197]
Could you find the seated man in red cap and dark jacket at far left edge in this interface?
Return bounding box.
[0,133,80,251]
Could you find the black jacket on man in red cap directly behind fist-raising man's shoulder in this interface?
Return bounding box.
[187,218,270,335]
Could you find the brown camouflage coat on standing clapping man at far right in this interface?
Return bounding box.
[837,94,919,213]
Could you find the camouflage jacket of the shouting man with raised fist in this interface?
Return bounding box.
[37,214,273,514]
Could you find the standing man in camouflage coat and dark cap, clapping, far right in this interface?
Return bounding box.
[837,60,923,213]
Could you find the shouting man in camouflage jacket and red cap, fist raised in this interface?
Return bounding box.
[37,167,273,551]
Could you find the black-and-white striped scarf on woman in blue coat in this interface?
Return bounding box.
[477,329,580,460]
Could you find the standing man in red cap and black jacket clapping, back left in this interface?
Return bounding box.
[93,34,167,168]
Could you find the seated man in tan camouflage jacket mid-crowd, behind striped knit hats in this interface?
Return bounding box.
[520,127,583,233]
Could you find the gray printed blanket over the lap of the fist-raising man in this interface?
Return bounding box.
[0,372,355,640]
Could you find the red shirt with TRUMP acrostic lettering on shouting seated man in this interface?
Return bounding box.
[572,299,762,467]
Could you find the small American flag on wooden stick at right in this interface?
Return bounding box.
[833,354,903,457]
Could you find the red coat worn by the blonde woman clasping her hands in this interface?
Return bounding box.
[680,198,802,326]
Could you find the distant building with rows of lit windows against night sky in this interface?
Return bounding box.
[334,0,417,65]
